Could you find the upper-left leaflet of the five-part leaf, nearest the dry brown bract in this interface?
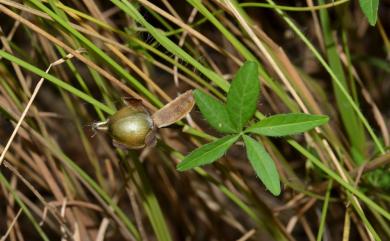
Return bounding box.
[194,90,238,133]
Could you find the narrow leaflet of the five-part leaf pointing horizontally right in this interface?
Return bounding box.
[245,113,329,136]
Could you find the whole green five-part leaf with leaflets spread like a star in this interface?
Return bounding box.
[177,61,329,196]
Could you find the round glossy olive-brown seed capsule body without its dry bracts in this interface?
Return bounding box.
[108,105,153,149]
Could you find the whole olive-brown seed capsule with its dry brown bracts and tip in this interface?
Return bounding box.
[92,90,195,149]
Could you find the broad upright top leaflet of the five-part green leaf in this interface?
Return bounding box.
[226,61,260,131]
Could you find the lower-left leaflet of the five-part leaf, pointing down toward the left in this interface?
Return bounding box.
[177,134,240,171]
